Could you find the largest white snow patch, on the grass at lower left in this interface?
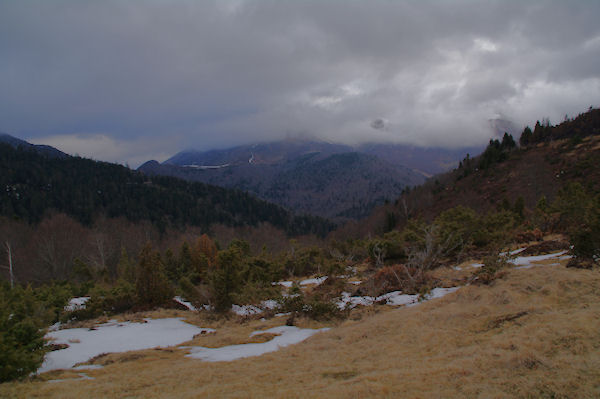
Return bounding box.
[38,318,214,373]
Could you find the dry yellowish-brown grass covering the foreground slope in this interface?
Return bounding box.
[0,260,600,398]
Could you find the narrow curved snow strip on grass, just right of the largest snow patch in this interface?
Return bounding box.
[186,326,329,362]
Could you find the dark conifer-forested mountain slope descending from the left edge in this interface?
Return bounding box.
[0,144,331,238]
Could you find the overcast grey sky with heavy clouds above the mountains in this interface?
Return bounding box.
[0,0,600,167]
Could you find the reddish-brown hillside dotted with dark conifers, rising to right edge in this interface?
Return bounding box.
[364,109,600,236]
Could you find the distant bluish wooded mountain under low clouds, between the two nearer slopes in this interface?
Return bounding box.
[138,140,424,221]
